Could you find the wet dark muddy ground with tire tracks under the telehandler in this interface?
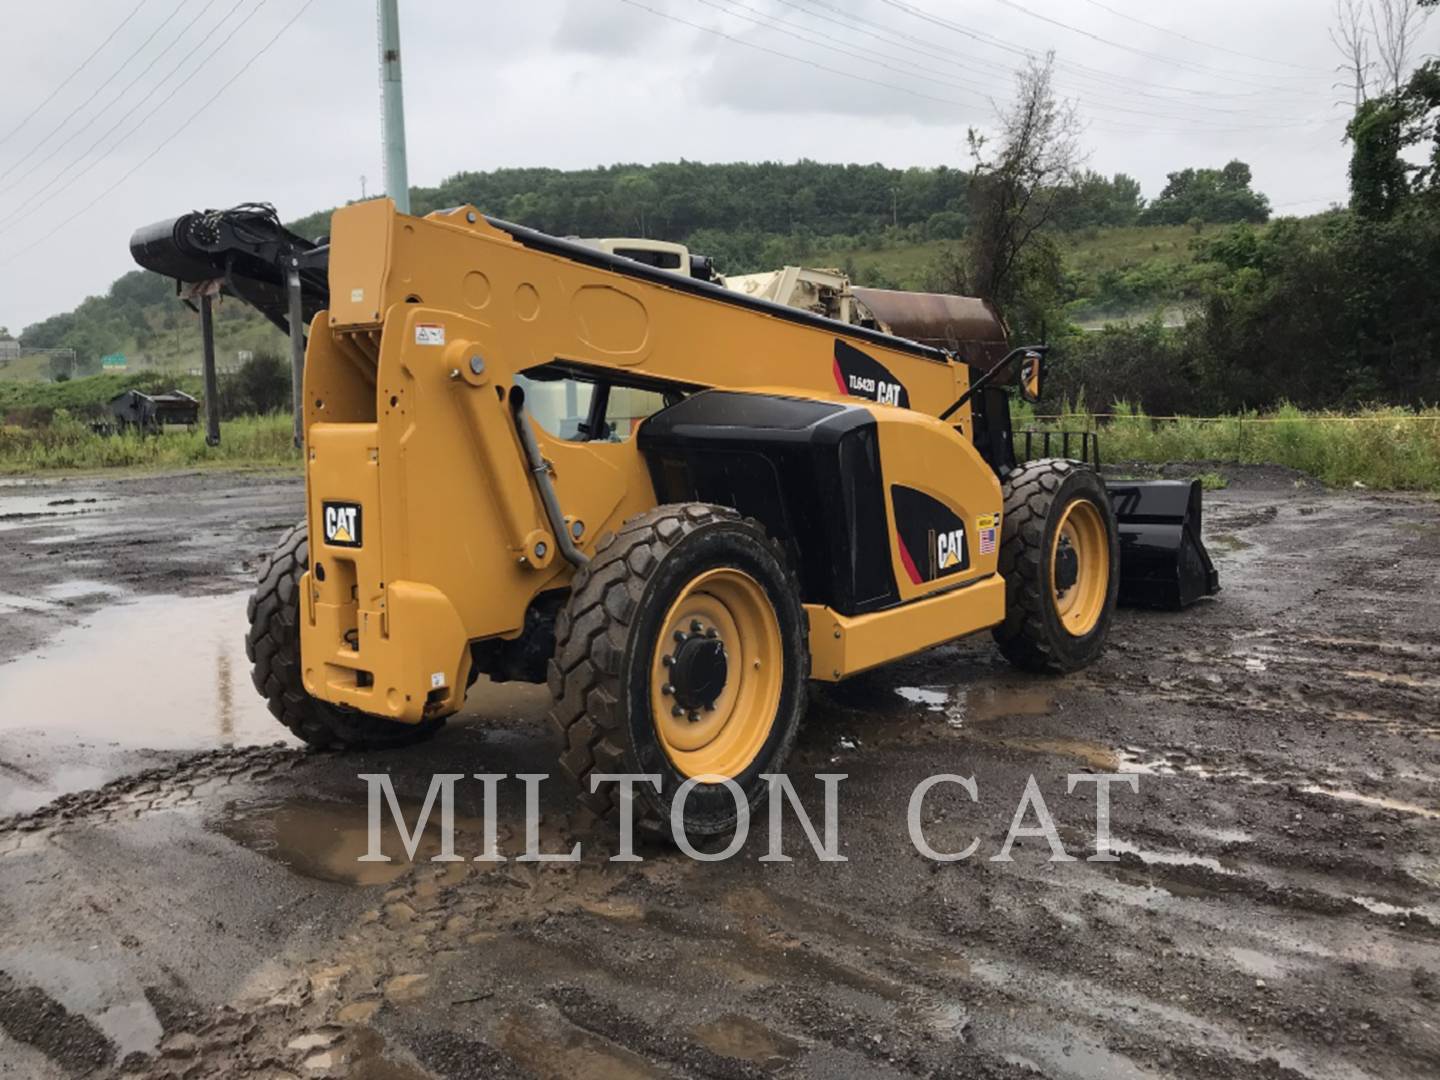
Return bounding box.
[0,469,1440,1080]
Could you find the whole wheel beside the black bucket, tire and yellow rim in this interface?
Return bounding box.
[994,458,1120,672]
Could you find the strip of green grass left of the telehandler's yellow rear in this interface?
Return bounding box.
[0,415,300,474]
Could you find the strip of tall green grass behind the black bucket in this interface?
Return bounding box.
[1021,405,1440,492]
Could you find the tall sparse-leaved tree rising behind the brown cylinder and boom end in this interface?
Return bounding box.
[956,53,1080,333]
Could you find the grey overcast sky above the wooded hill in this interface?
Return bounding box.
[0,0,1440,333]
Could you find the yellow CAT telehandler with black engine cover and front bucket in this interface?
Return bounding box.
[131,199,1218,837]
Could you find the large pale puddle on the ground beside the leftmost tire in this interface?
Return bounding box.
[0,593,288,750]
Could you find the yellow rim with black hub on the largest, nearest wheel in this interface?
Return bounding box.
[649,567,783,778]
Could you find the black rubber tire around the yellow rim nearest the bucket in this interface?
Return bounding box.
[992,458,1120,674]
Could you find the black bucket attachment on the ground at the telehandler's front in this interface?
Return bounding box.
[1106,480,1220,611]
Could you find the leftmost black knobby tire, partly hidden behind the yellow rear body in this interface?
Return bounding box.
[245,521,445,750]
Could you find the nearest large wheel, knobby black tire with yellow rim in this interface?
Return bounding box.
[549,503,809,838]
